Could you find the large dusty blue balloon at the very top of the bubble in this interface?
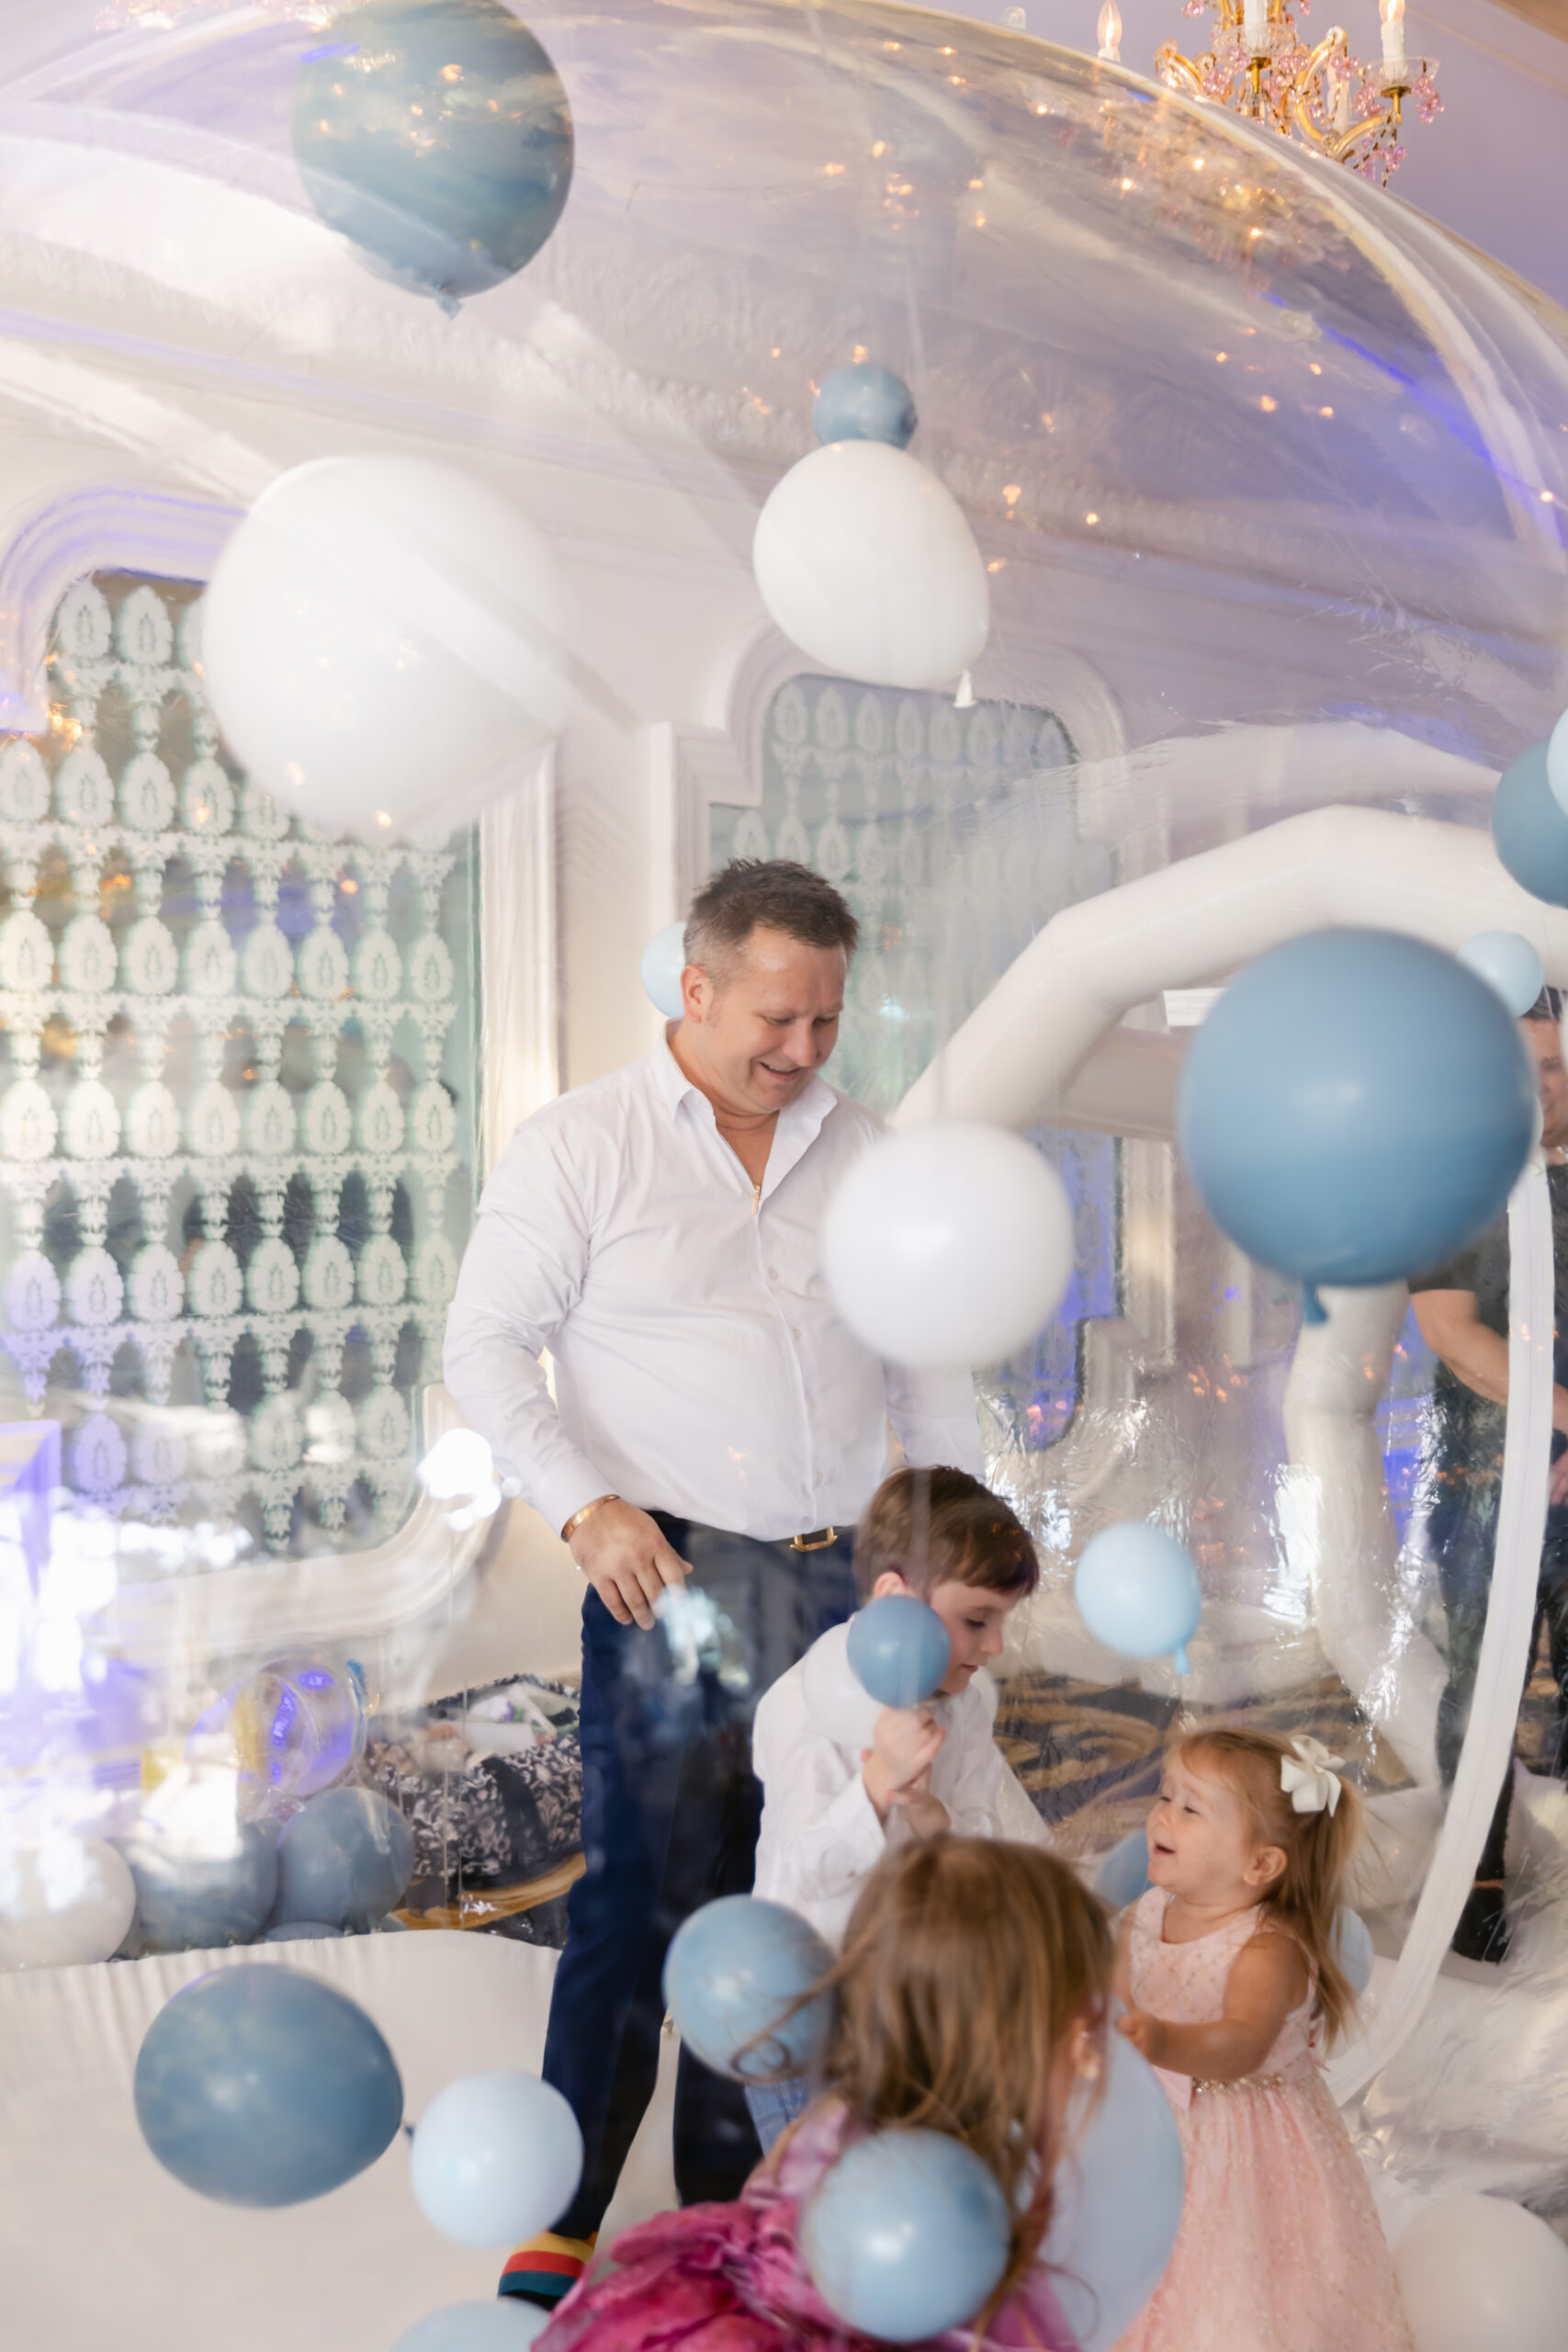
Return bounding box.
[291,0,571,311]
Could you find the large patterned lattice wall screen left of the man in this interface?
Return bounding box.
[0,576,475,1550]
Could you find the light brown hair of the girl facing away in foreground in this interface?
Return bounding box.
[799,1837,1112,2317]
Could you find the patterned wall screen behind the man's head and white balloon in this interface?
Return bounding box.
[710,677,1119,1446]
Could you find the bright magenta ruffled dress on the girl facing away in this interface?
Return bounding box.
[536,2108,1079,2352]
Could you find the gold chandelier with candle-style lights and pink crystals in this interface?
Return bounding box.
[1100,0,1443,186]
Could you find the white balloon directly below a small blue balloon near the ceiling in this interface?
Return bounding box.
[752,442,989,687]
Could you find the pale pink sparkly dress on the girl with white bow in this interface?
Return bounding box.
[1114,1886,1413,2352]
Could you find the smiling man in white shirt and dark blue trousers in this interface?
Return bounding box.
[446,864,980,2305]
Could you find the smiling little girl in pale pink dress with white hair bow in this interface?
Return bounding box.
[1114,1729,1411,2352]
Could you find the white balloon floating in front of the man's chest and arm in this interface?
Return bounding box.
[823,1120,1072,1371]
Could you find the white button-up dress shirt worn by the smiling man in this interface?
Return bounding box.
[445,1045,983,1538]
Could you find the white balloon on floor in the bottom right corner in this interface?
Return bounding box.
[1394,2197,1568,2352]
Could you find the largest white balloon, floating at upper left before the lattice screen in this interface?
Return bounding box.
[202,457,576,842]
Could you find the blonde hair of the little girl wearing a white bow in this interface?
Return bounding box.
[1170,1729,1361,2041]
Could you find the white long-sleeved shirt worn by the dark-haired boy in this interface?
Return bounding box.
[752,1634,1048,1952]
